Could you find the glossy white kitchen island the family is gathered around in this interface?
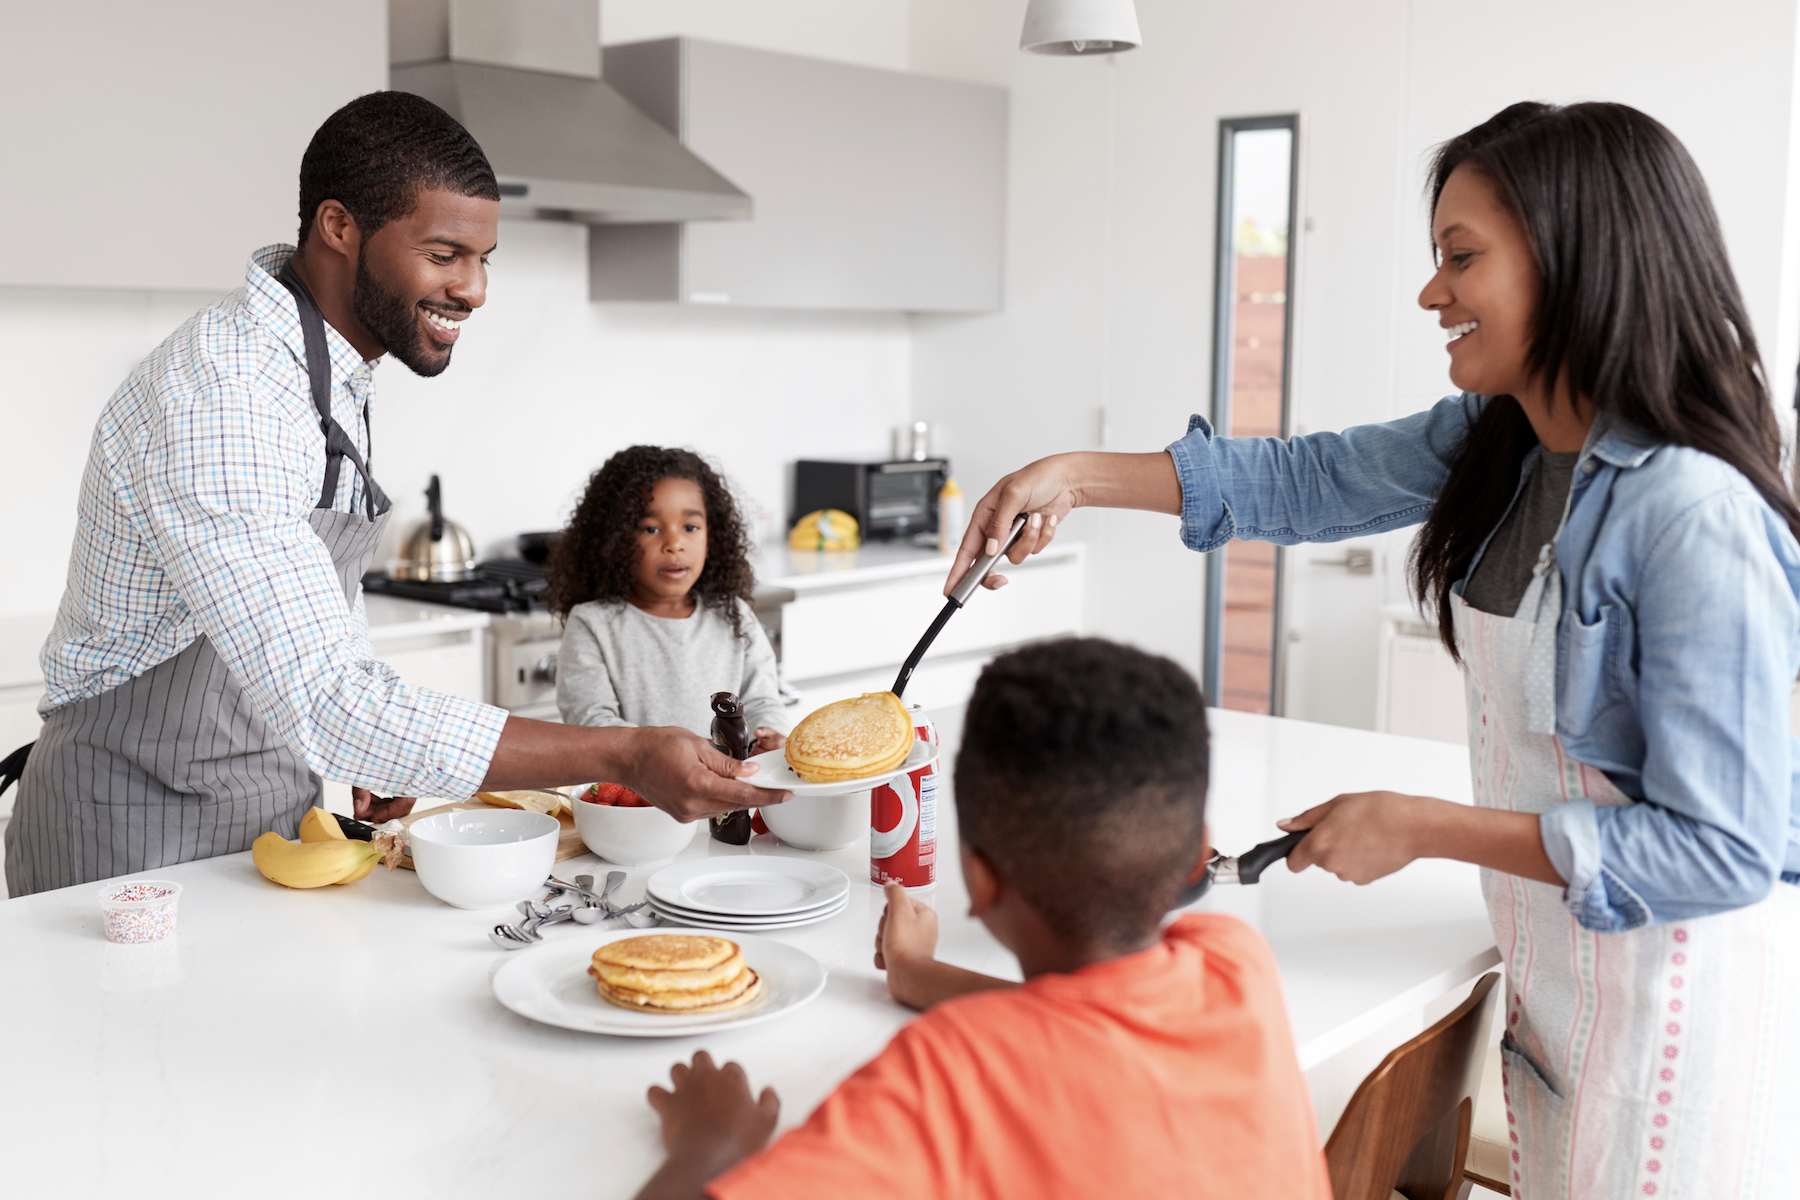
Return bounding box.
[0,712,1496,1200]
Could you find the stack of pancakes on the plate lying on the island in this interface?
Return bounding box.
[587,934,763,1013]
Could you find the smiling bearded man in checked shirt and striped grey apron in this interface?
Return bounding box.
[0,92,787,896]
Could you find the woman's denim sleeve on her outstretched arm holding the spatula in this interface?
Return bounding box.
[1168,394,1487,551]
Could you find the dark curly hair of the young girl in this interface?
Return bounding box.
[545,446,756,637]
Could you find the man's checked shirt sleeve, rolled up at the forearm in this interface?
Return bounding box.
[135,374,506,797]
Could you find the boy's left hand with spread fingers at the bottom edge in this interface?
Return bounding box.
[637,1051,781,1200]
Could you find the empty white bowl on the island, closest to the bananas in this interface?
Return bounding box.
[407,808,562,909]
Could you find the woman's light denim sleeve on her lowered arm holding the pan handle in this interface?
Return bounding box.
[1539,489,1800,932]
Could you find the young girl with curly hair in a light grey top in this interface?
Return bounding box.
[549,446,787,754]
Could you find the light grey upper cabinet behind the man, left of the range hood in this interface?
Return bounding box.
[0,0,387,291]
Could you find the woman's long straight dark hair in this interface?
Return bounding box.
[1411,103,1800,655]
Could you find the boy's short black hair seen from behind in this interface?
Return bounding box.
[956,637,1208,943]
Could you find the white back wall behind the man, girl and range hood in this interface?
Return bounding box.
[0,0,911,629]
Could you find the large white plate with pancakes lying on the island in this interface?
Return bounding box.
[493,928,824,1038]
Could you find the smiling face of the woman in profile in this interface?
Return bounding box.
[1418,166,1537,401]
